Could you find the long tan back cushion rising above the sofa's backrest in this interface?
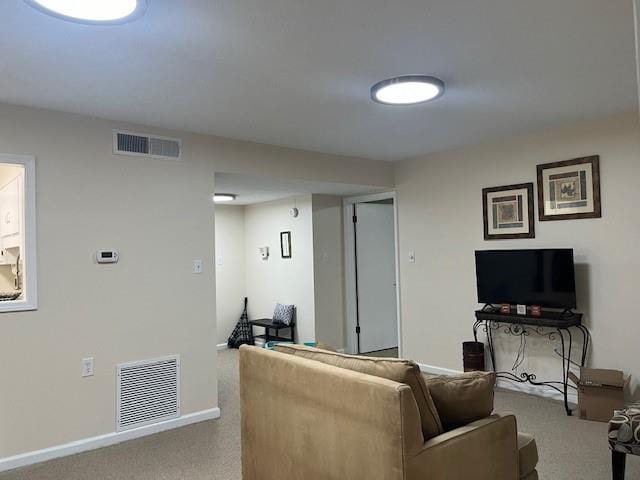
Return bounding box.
[274,344,444,441]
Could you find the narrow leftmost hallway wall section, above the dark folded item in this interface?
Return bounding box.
[215,205,247,344]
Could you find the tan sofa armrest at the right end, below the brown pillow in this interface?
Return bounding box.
[405,415,519,480]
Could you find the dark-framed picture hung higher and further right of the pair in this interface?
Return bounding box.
[537,155,602,222]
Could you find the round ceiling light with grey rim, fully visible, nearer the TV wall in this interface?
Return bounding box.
[371,75,444,105]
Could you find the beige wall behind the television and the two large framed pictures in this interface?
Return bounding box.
[396,112,640,398]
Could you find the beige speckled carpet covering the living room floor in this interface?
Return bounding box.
[0,350,640,480]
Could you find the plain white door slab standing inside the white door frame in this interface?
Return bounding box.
[355,203,398,353]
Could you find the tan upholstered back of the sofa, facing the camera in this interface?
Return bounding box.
[240,345,424,480]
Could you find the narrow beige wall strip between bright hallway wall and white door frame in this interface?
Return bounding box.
[313,195,346,348]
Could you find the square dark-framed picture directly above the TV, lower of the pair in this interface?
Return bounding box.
[482,183,536,240]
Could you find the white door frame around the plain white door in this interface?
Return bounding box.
[342,191,403,357]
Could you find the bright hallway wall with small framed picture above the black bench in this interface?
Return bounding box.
[245,195,315,342]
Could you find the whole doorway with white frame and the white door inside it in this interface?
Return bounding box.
[344,192,401,357]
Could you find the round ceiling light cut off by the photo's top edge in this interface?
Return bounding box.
[25,0,147,25]
